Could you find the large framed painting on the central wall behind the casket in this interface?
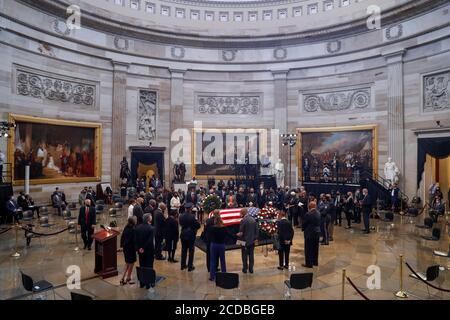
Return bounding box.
[192,129,266,179]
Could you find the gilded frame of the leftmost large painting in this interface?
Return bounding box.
[8,113,102,186]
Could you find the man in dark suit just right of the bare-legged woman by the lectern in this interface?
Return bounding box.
[134,213,155,289]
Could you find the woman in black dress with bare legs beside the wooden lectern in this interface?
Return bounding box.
[120,216,136,285]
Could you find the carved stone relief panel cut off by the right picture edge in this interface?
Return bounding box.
[423,70,450,112]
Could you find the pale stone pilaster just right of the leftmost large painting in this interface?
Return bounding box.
[111,61,130,191]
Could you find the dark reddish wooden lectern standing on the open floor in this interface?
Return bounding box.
[94,229,120,279]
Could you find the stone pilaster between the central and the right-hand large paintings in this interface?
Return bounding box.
[271,70,290,185]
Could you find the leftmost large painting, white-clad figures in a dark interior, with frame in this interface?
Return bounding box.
[8,114,101,184]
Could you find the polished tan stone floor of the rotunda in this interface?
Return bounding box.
[0,205,450,300]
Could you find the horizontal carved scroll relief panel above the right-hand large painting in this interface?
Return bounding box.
[303,88,371,112]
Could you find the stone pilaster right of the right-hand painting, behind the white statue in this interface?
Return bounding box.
[385,50,405,189]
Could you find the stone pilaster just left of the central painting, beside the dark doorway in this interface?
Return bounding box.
[167,69,185,181]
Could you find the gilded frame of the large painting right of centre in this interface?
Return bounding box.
[296,124,378,181]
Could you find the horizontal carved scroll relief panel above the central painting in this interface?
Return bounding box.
[197,94,262,115]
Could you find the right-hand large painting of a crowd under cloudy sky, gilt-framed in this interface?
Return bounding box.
[297,125,377,184]
